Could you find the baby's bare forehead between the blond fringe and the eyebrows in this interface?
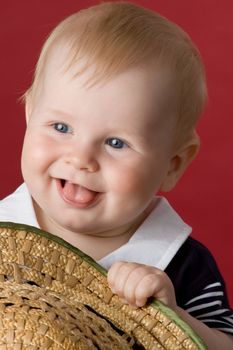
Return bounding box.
[36,45,175,129]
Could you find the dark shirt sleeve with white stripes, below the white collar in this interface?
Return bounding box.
[165,238,233,335]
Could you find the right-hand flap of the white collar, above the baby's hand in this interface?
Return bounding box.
[99,197,192,270]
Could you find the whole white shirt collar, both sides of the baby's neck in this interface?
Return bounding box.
[0,184,192,270]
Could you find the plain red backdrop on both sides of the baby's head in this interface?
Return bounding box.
[0,0,233,304]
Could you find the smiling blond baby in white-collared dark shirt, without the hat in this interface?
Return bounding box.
[0,2,233,350]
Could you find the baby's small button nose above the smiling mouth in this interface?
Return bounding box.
[65,146,99,173]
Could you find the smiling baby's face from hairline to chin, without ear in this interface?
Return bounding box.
[22,50,175,235]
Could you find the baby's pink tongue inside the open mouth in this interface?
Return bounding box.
[63,181,96,204]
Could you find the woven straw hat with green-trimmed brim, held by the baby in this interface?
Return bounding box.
[0,223,206,350]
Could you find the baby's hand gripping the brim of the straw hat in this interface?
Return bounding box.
[108,261,177,309]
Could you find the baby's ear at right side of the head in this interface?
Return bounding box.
[160,131,200,192]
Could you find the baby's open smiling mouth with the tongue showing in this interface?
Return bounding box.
[58,179,100,208]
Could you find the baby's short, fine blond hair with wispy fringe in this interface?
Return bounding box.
[25,2,207,145]
